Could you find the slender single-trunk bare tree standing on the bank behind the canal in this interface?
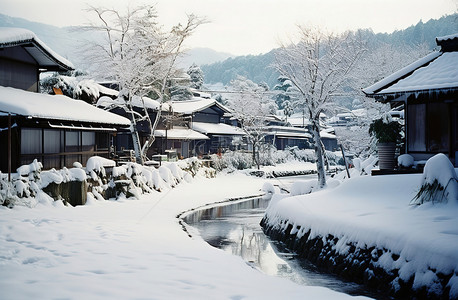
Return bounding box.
[274,26,365,187]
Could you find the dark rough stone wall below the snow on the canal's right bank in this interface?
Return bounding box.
[261,217,453,299]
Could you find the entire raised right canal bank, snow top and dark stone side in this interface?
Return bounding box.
[263,174,458,299]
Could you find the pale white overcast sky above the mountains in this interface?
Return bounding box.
[0,0,458,55]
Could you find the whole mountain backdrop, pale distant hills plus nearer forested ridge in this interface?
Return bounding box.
[0,14,458,88]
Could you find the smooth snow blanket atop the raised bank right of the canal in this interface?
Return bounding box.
[266,168,458,299]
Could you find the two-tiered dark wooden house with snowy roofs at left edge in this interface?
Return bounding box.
[0,28,130,172]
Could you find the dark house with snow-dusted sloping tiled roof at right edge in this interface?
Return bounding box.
[363,34,458,166]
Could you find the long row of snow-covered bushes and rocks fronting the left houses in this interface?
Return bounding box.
[0,156,197,207]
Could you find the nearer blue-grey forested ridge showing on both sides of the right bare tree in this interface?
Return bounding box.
[201,14,458,88]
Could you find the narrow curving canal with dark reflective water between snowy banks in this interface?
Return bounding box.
[183,188,388,299]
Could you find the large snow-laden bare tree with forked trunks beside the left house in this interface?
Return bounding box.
[81,5,205,163]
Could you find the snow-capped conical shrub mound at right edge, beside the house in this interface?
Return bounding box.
[411,153,458,205]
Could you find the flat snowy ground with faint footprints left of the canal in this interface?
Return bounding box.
[0,173,366,299]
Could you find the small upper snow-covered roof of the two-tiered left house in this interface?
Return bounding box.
[0,27,74,71]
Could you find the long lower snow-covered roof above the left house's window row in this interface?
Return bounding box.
[0,86,130,126]
